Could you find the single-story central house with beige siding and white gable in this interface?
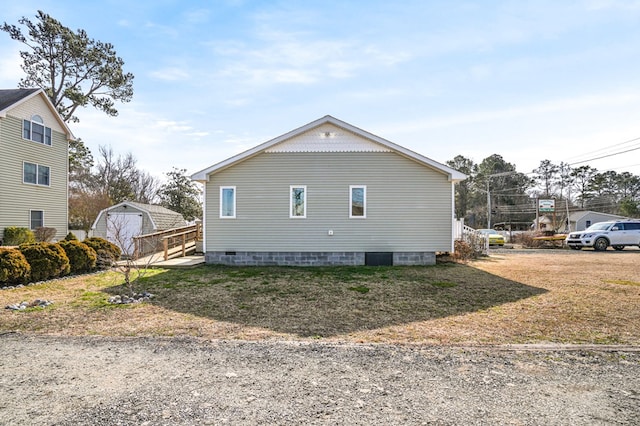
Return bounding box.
[192,116,465,265]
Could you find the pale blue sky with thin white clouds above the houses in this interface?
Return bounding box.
[0,0,640,178]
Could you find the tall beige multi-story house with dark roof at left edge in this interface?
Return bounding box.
[0,89,73,240]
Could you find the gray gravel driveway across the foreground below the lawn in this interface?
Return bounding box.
[0,334,640,425]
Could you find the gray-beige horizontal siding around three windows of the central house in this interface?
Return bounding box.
[205,152,453,253]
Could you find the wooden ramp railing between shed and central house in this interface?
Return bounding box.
[133,224,202,260]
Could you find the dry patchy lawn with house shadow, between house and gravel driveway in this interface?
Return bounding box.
[0,251,640,344]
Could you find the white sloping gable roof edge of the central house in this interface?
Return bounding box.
[191,115,467,182]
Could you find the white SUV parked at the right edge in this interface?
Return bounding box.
[565,219,640,251]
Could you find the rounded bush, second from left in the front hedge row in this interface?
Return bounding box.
[19,242,71,282]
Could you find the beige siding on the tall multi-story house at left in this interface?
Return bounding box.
[0,111,68,240]
